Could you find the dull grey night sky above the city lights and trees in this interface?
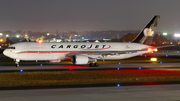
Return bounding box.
[0,0,180,33]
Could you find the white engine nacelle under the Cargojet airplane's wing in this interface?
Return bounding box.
[71,55,96,65]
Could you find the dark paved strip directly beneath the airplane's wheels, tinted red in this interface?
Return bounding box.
[0,62,180,72]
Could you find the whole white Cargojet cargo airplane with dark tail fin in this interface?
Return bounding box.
[3,16,160,67]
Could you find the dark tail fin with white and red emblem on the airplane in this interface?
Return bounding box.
[132,15,160,44]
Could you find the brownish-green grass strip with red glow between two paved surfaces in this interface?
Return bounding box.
[0,70,180,87]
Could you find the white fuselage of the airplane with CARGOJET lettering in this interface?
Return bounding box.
[3,42,150,60]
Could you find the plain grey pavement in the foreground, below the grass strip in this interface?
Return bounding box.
[0,84,180,101]
